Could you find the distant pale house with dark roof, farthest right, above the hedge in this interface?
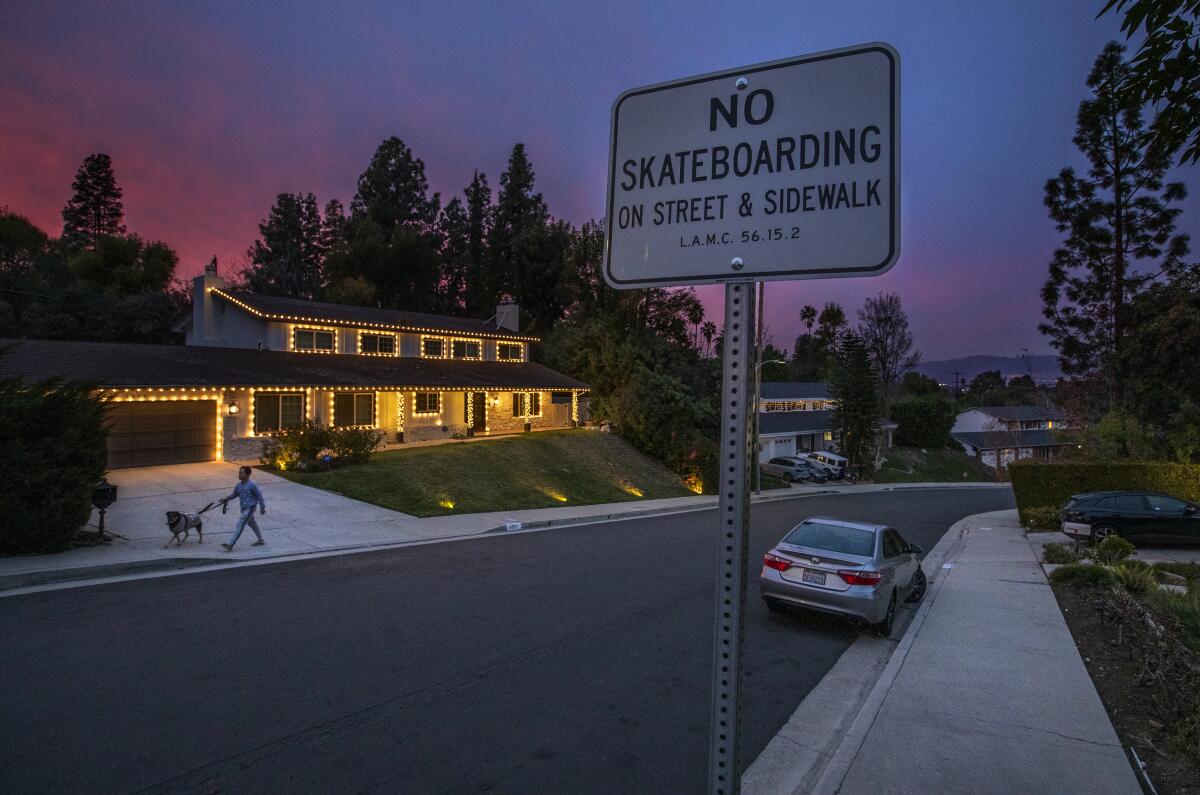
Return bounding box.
[950,406,1072,468]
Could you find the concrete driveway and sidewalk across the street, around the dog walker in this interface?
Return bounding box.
[0,470,1007,592]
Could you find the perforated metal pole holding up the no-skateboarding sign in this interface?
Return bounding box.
[708,282,756,795]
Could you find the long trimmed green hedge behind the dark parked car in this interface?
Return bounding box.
[1008,461,1200,525]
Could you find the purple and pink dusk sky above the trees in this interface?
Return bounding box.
[0,0,1200,359]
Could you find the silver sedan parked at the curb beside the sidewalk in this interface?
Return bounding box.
[758,518,926,636]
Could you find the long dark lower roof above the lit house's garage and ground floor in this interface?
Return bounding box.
[0,340,588,390]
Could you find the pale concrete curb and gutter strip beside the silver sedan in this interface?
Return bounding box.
[742,514,986,795]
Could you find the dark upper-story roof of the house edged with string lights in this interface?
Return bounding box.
[212,289,538,342]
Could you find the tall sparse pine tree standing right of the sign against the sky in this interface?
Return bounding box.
[1038,42,1188,402]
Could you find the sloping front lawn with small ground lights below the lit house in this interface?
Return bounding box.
[278,430,692,516]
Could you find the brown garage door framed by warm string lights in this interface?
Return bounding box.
[108,400,217,470]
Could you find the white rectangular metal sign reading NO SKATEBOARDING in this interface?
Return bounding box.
[605,43,900,288]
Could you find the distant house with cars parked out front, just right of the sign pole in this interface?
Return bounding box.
[758,381,896,461]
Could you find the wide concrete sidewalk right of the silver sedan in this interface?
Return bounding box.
[745,510,1141,795]
